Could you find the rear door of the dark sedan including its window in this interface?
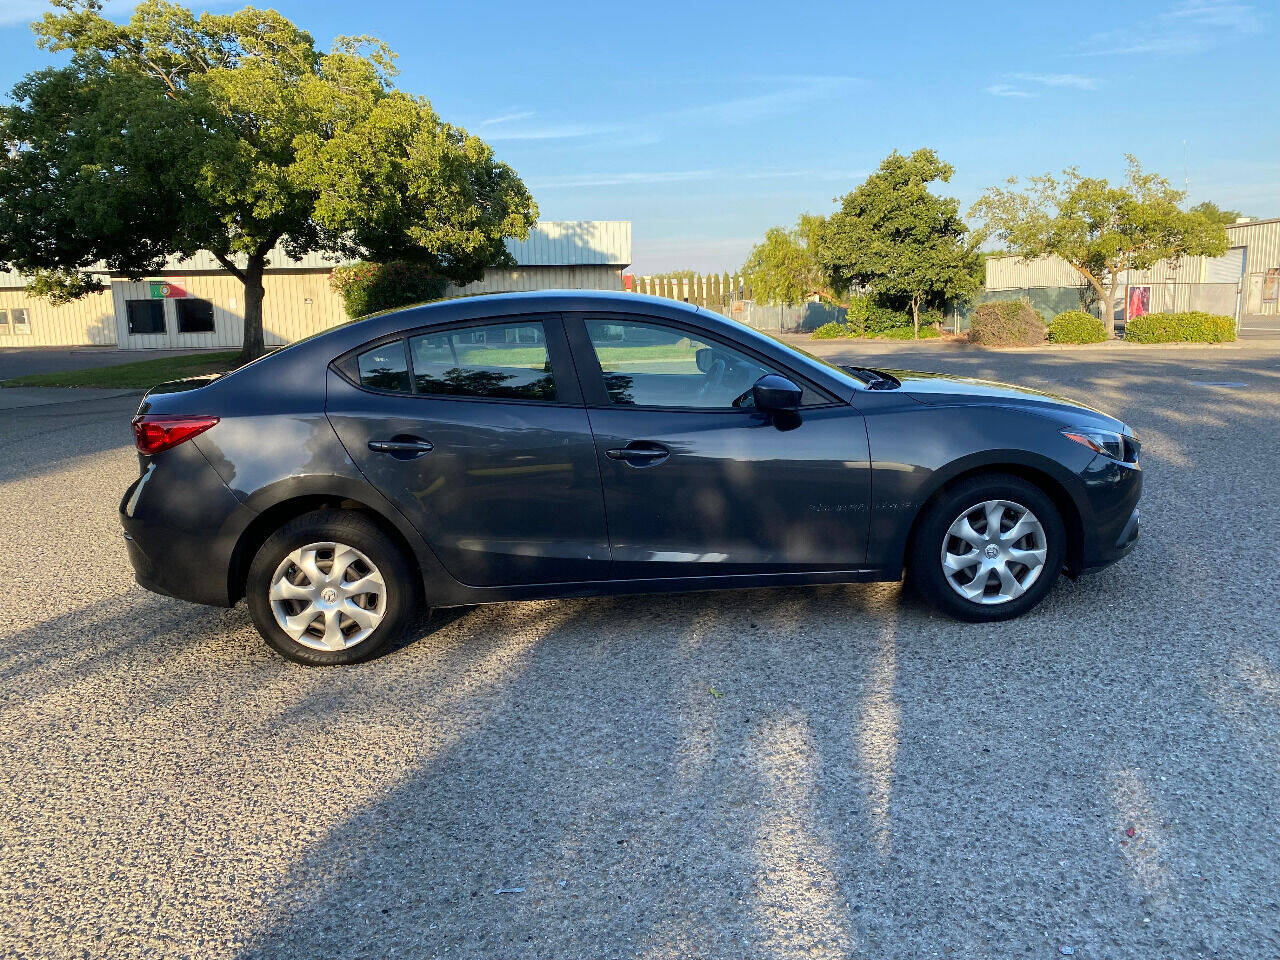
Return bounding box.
[326,316,609,586]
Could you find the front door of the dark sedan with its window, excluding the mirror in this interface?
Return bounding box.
[567,316,870,579]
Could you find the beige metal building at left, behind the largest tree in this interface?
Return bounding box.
[0,220,631,349]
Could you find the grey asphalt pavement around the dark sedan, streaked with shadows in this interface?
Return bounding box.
[0,344,1280,959]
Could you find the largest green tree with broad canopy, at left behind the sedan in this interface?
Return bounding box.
[0,0,538,358]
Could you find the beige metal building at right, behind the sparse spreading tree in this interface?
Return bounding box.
[986,218,1280,326]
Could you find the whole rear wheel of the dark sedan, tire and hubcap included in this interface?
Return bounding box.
[246,511,417,664]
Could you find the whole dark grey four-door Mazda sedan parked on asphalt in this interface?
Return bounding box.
[120,292,1142,664]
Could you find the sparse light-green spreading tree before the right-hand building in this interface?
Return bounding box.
[969,156,1226,335]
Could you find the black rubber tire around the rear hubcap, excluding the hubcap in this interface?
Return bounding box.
[244,509,420,666]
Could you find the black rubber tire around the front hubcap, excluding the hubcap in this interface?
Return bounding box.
[909,474,1066,623]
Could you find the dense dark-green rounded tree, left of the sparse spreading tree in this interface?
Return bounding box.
[817,148,980,337]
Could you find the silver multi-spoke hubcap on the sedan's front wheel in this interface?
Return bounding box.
[942,500,1048,604]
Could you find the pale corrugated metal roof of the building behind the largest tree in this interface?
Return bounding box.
[0,220,631,287]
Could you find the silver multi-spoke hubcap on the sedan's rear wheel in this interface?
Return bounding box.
[271,543,387,650]
